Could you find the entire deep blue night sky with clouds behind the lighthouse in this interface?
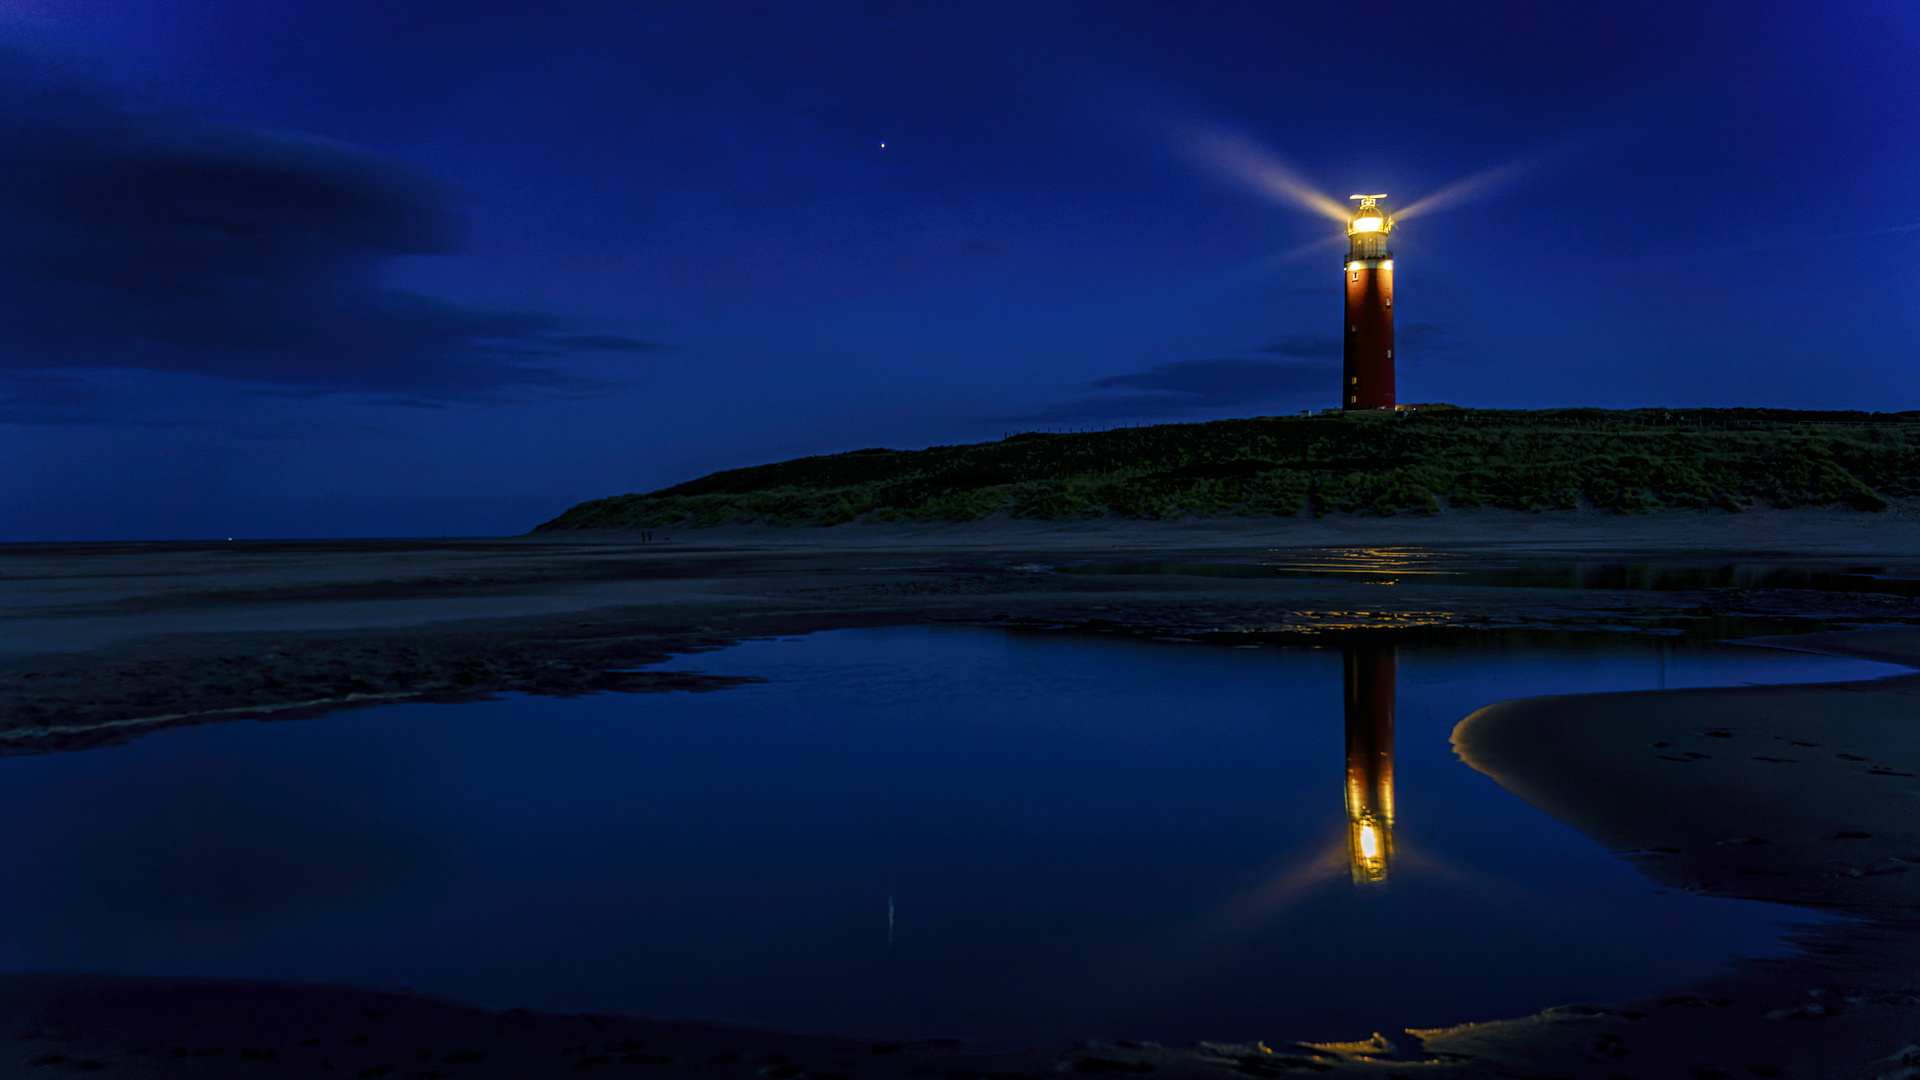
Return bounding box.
[0,0,1920,540]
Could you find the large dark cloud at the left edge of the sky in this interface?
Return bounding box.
[0,50,655,400]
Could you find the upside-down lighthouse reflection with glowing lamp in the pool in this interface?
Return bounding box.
[1344,646,1394,888]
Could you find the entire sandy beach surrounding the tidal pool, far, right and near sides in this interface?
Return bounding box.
[0,511,1920,1080]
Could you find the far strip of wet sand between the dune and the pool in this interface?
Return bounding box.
[11,511,1920,753]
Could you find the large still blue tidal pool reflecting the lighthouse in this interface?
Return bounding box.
[0,628,1903,1047]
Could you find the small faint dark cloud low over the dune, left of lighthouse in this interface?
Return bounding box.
[1016,355,1338,423]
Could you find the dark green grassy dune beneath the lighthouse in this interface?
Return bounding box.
[540,409,1920,530]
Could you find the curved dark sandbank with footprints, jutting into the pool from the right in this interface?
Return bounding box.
[1427,626,1920,1076]
